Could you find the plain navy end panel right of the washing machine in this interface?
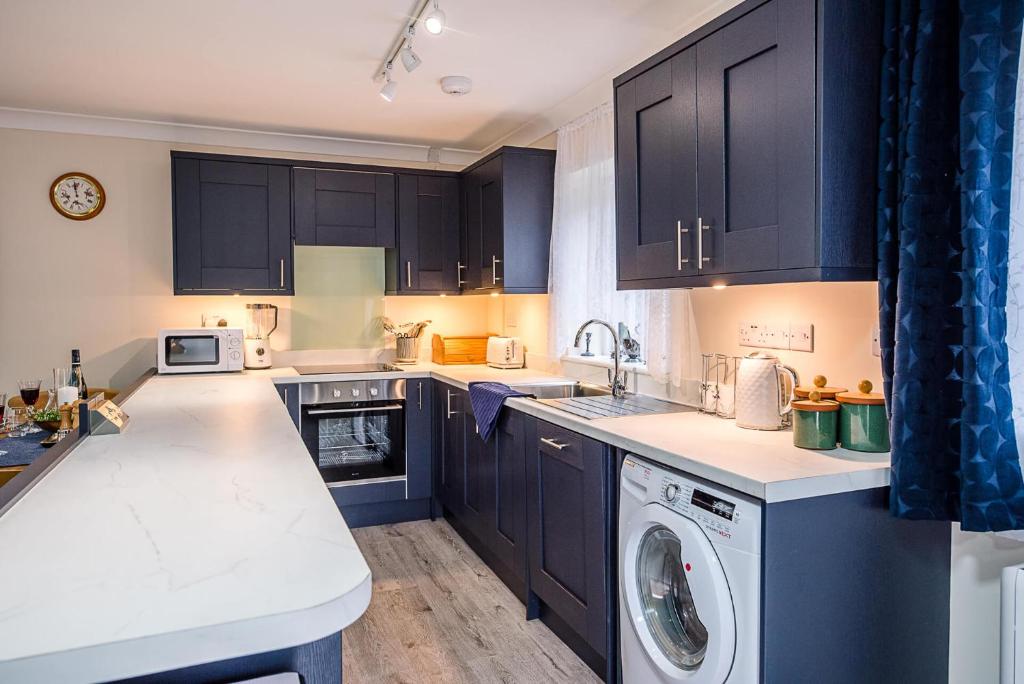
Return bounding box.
[761,487,950,684]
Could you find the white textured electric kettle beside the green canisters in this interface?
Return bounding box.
[736,351,797,430]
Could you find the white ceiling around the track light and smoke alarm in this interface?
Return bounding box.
[0,0,735,149]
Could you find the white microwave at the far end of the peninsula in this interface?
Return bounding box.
[157,328,245,373]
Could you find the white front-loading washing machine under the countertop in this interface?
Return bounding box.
[618,455,761,684]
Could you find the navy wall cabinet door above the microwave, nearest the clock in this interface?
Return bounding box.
[171,153,294,295]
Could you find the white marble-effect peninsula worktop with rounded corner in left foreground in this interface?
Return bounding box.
[0,374,371,683]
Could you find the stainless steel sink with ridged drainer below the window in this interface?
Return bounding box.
[512,382,695,420]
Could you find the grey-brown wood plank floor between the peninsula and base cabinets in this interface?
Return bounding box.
[342,520,600,684]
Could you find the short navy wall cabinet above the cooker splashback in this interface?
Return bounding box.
[293,167,395,247]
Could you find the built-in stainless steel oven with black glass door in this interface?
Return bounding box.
[299,380,406,486]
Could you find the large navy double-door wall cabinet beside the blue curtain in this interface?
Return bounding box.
[615,0,881,289]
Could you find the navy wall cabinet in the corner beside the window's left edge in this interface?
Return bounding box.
[457,147,555,294]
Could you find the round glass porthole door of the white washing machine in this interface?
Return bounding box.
[622,504,736,684]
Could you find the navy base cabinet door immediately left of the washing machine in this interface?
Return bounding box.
[524,419,615,681]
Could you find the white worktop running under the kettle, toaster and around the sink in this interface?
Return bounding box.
[267,362,889,503]
